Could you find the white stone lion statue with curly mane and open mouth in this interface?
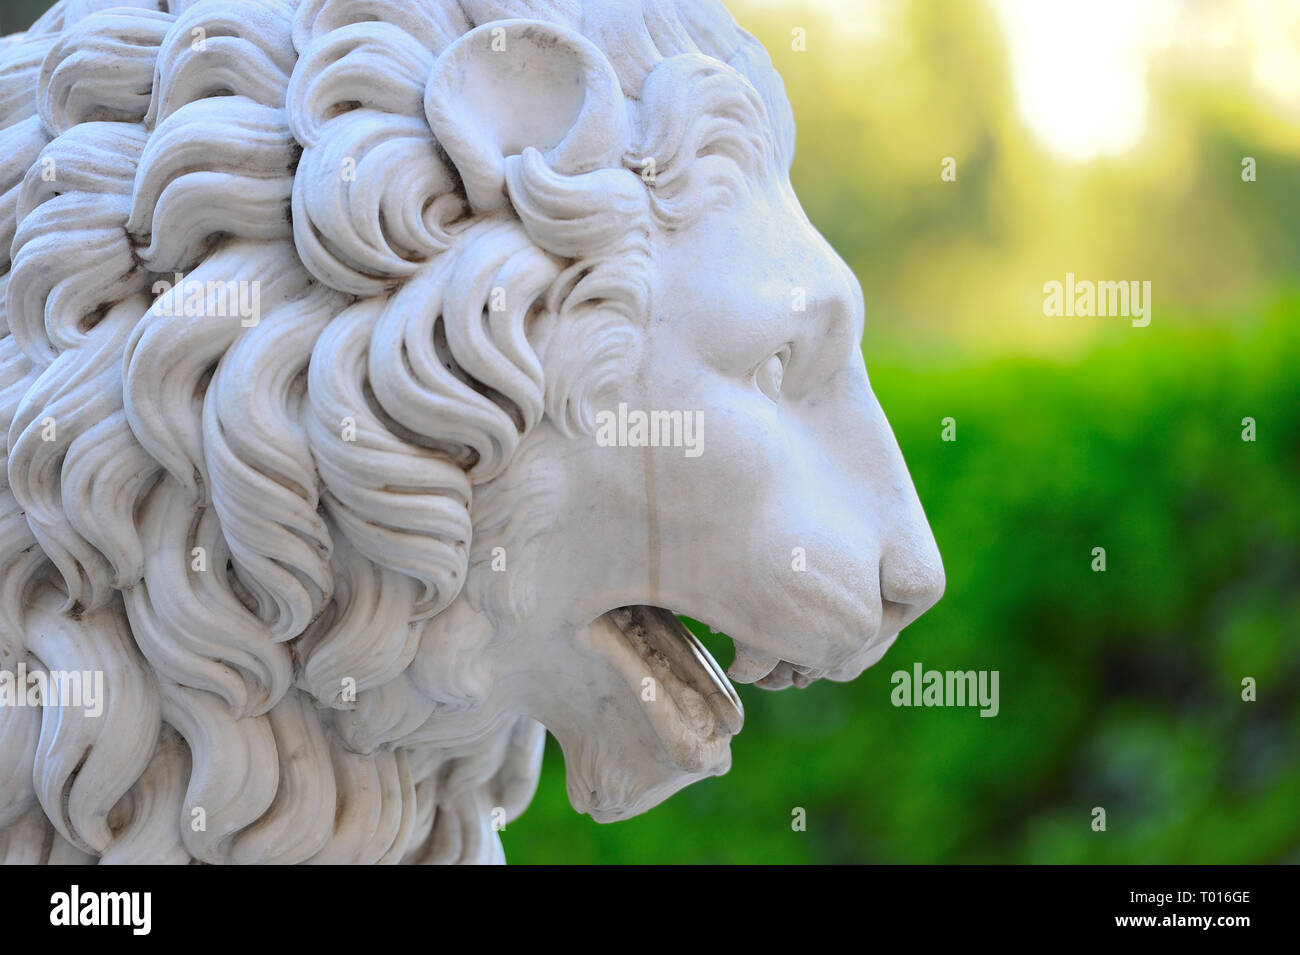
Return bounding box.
[0,0,944,863]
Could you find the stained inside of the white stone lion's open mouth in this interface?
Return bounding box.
[592,604,822,770]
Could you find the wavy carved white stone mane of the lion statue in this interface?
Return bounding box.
[0,0,793,863]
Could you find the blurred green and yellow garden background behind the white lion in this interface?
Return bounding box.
[0,0,1300,863]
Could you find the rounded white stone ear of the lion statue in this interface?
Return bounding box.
[424,19,629,212]
